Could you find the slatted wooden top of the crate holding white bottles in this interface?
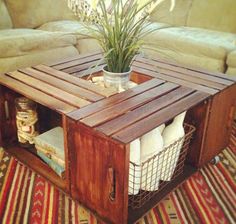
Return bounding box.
[71,79,210,144]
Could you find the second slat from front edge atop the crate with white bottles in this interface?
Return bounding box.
[96,86,195,136]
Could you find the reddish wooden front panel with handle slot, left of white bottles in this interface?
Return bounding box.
[68,121,129,223]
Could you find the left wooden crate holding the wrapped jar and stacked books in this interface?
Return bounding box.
[0,65,114,193]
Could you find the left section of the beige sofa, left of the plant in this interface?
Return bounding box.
[0,0,82,72]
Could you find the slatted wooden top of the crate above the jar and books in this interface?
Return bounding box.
[0,62,116,114]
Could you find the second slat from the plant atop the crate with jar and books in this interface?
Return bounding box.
[19,68,104,102]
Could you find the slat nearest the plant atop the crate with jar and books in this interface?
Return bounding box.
[33,65,116,97]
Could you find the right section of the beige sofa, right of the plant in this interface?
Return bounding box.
[145,0,236,75]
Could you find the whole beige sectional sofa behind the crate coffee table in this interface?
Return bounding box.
[0,0,236,75]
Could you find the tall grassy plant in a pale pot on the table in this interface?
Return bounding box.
[67,0,174,89]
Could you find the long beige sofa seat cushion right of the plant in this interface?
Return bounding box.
[145,27,236,59]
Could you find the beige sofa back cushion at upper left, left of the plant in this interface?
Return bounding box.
[6,0,74,28]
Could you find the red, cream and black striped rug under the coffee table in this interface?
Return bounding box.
[0,124,236,224]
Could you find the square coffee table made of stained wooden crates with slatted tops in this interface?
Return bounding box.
[0,53,236,224]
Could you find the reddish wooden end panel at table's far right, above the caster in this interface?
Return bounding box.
[198,85,236,167]
